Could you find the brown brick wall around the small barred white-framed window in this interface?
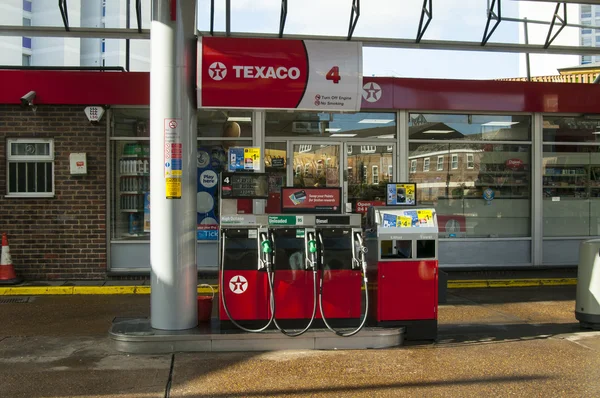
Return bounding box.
[0,105,108,280]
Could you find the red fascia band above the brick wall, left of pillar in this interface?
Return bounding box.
[0,70,150,105]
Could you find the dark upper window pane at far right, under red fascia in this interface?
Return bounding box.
[543,115,600,143]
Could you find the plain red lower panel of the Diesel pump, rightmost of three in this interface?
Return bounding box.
[317,270,364,319]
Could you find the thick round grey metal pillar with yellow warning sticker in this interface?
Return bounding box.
[150,0,198,330]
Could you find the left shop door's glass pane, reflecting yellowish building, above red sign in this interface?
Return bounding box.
[288,142,342,188]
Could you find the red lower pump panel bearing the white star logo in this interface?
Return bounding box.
[219,270,270,321]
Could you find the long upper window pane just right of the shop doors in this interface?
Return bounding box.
[409,114,531,141]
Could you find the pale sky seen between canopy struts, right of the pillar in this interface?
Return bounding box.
[198,0,579,79]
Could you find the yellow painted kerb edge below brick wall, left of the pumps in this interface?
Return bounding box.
[0,285,219,296]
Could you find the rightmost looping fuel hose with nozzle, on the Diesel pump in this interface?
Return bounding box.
[317,229,369,337]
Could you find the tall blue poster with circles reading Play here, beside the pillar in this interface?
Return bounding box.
[196,147,226,241]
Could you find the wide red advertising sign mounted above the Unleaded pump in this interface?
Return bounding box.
[281,188,342,214]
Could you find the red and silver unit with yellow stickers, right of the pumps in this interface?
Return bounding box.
[366,206,438,340]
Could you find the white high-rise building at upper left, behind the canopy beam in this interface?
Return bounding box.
[0,0,150,71]
